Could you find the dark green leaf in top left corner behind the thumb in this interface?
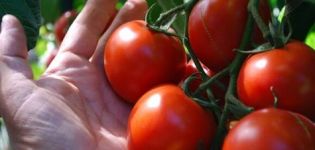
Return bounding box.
[0,0,41,49]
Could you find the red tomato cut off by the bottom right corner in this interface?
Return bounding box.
[223,108,315,150]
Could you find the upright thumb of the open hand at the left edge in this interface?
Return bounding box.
[0,15,32,79]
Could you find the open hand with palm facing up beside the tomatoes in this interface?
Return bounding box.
[0,0,147,150]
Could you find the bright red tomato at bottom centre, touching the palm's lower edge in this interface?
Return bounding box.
[128,85,216,150]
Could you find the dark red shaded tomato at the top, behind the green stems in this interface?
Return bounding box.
[188,0,269,72]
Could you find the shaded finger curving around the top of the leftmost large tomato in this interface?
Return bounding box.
[91,0,147,68]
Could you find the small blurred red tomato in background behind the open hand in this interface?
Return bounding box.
[55,11,77,45]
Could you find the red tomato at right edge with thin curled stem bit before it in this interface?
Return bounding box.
[237,41,315,121]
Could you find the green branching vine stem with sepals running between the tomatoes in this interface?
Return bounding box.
[147,0,315,149]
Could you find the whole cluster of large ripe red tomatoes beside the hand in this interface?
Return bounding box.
[104,0,315,150]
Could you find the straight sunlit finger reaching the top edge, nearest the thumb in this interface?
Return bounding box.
[57,0,117,59]
